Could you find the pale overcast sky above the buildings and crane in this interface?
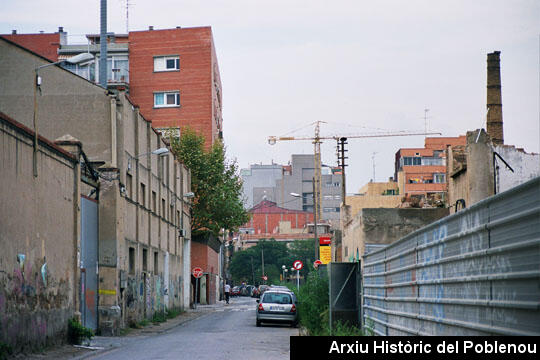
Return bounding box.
[0,0,540,193]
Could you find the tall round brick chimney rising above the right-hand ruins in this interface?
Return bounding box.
[487,51,504,145]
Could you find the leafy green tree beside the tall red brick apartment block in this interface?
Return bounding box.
[170,128,249,236]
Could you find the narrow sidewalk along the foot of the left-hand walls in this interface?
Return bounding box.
[17,301,225,360]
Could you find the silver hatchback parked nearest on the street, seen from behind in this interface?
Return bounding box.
[256,290,298,327]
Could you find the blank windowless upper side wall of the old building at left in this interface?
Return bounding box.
[0,38,114,165]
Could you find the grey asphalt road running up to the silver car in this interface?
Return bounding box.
[90,297,298,360]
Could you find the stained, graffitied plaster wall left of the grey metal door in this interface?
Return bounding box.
[0,114,79,351]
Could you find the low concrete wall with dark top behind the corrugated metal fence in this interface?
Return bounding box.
[342,208,449,261]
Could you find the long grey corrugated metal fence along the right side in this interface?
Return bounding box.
[363,178,540,335]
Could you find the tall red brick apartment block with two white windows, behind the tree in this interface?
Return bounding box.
[129,27,223,146]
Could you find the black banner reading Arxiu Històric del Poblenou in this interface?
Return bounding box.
[290,336,539,360]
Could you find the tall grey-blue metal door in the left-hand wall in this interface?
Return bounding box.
[81,197,98,330]
